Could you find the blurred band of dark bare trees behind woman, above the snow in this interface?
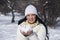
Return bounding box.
[0,0,60,26]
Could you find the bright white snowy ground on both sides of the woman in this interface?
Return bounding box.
[0,16,60,40]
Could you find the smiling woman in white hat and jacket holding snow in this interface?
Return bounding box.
[17,5,46,40]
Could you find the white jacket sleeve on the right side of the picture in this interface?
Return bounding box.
[37,24,46,40]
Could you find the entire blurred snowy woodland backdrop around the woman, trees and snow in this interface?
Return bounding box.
[0,0,60,40]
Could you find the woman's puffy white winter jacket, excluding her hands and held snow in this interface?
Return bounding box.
[17,22,46,40]
